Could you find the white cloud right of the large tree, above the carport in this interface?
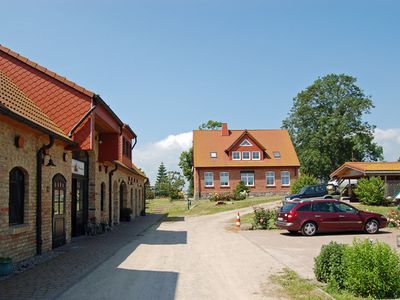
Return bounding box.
[375,128,400,161]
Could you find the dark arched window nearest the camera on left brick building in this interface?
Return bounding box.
[8,168,25,225]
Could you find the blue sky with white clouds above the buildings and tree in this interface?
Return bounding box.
[0,0,400,182]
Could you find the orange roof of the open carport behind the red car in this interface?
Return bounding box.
[331,162,400,177]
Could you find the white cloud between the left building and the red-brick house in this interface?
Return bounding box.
[133,132,193,185]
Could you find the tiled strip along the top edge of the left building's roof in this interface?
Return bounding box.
[0,44,94,97]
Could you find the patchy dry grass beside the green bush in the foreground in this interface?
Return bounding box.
[271,268,366,300]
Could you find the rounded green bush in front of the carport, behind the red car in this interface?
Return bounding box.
[354,177,386,205]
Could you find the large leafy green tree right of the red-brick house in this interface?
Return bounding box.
[282,74,383,179]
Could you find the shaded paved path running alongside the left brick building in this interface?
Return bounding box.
[0,215,163,300]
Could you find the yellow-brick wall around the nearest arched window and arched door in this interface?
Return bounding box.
[0,118,71,261]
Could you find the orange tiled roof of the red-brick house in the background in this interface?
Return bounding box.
[193,129,300,168]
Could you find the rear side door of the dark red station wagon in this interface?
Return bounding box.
[312,201,339,231]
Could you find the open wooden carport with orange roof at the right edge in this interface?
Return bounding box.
[331,162,400,197]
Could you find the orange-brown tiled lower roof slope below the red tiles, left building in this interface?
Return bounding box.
[0,71,70,141]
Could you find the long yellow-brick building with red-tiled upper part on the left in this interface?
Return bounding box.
[0,45,147,260]
